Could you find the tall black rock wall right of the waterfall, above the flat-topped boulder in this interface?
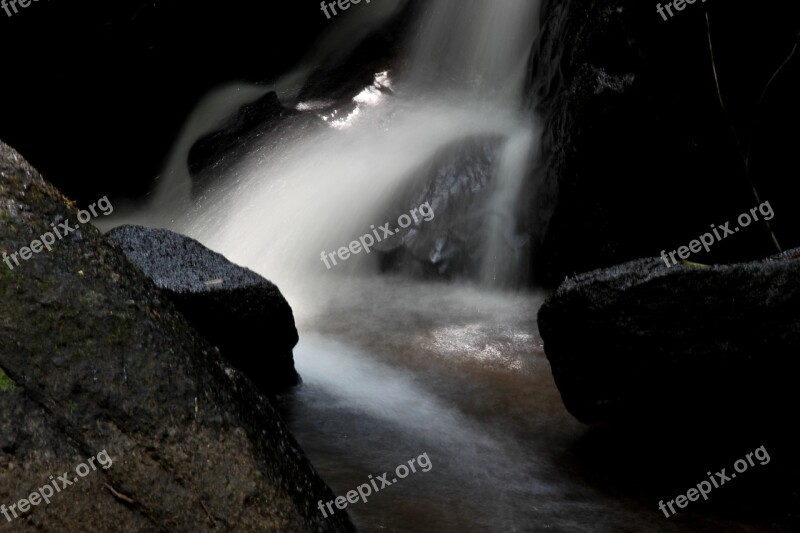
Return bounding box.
[530,0,800,286]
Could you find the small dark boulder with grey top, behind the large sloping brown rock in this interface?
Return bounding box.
[106,222,300,393]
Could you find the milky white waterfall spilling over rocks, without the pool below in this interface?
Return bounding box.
[115,0,538,296]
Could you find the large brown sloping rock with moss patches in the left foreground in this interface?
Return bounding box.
[0,139,353,532]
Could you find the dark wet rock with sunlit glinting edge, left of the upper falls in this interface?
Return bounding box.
[188,0,416,196]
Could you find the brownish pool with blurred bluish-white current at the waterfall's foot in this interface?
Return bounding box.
[283,277,757,532]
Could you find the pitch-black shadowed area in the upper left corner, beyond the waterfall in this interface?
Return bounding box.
[0,0,333,203]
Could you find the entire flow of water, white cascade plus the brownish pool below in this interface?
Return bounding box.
[106,0,664,532]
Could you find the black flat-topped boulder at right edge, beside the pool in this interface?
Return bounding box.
[539,250,800,423]
